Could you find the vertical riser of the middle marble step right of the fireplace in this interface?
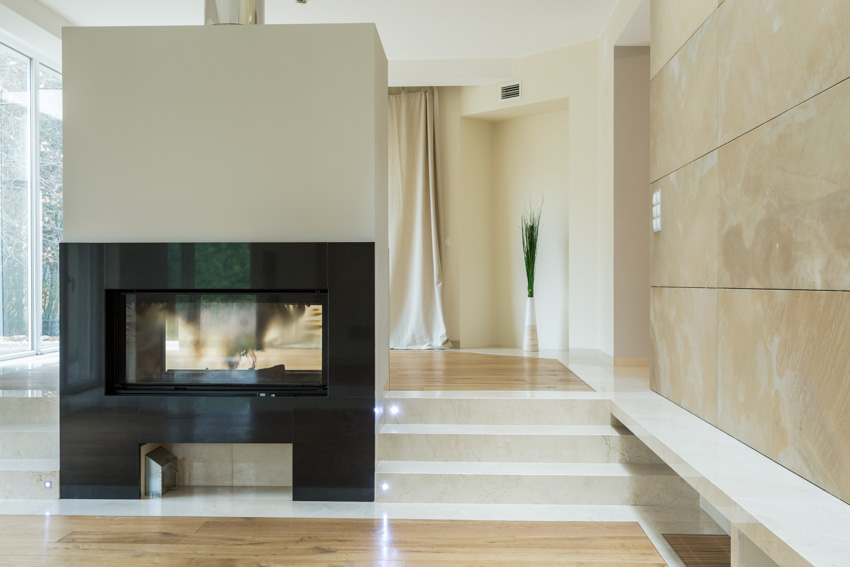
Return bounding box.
[378,433,661,463]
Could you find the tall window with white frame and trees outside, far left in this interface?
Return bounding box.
[0,43,62,359]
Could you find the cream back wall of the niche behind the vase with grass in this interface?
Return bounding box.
[491,110,570,350]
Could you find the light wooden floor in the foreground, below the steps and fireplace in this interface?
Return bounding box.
[0,516,665,567]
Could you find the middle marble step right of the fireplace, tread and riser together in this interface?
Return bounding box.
[378,424,661,464]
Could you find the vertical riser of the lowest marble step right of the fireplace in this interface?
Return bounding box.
[375,473,699,507]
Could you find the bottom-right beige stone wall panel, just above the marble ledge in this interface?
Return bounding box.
[717,290,850,501]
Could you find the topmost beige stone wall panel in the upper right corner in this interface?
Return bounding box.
[717,0,850,144]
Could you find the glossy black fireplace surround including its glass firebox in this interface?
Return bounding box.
[60,243,375,501]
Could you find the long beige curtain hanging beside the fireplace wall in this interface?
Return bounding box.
[389,87,452,349]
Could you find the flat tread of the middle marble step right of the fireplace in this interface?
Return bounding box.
[381,423,630,436]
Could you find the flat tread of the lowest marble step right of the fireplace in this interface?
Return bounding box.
[375,461,676,476]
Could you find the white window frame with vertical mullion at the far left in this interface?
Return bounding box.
[0,29,64,362]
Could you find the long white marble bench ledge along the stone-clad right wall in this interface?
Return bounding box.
[611,393,850,567]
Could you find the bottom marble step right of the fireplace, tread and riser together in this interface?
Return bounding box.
[375,461,699,507]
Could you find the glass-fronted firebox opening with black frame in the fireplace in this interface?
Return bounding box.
[106,290,328,396]
